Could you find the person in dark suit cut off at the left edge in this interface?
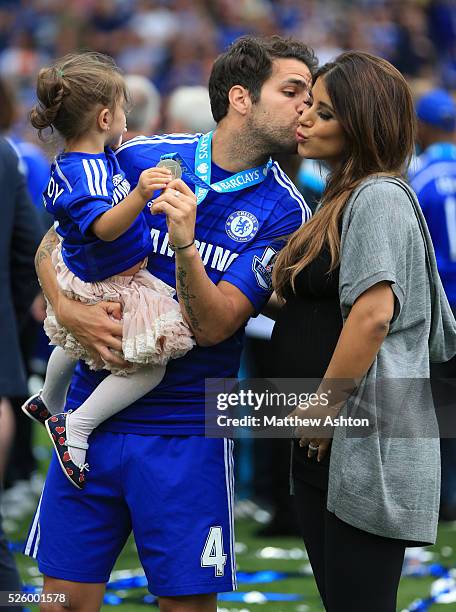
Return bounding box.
[0,138,42,610]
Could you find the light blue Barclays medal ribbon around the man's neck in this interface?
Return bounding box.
[160,132,273,204]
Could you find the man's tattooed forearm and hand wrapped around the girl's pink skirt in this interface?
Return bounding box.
[35,228,125,366]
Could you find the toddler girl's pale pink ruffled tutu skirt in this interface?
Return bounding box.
[44,246,195,375]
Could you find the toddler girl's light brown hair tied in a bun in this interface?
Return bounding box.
[30,51,128,140]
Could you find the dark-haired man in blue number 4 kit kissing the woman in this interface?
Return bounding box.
[26,37,315,612]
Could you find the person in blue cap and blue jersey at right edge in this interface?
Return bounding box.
[411,90,456,521]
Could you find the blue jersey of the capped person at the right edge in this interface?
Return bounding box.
[410,143,456,307]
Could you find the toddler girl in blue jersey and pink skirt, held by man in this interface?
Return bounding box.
[22,52,195,489]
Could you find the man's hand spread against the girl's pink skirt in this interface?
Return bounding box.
[56,295,127,367]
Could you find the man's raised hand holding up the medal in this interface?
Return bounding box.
[150,179,196,247]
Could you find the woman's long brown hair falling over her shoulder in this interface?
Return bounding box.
[273,51,416,297]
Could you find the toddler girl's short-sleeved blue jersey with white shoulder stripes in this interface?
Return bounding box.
[43,149,151,282]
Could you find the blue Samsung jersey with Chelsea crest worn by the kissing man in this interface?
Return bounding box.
[67,134,310,435]
